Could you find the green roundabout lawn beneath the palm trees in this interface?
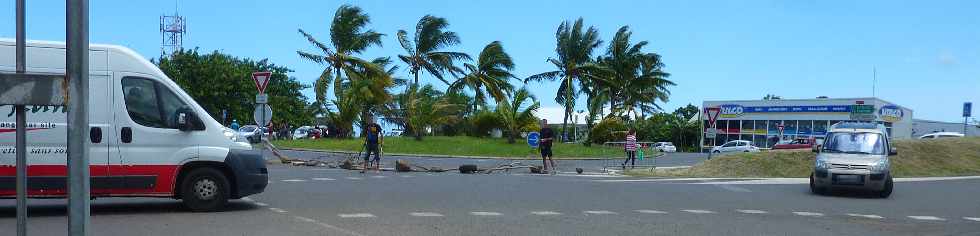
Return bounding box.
[273,136,623,159]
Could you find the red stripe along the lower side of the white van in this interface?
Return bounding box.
[0,165,180,197]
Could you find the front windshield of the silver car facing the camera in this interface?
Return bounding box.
[823,132,885,155]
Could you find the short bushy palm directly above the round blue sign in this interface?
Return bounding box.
[497,87,541,143]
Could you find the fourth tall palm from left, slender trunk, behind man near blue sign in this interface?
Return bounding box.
[524,18,602,141]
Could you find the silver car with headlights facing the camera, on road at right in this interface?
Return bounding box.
[810,122,898,198]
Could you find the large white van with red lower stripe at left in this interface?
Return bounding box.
[0,39,268,211]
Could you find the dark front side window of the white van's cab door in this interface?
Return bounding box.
[122,77,187,129]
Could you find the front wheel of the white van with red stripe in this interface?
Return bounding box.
[180,167,231,212]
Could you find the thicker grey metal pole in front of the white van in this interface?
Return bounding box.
[65,0,90,236]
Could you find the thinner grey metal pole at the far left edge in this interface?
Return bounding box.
[14,0,27,236]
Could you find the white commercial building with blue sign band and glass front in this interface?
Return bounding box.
[701,97,913,148]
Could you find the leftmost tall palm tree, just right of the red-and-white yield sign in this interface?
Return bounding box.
[296,5,384,104]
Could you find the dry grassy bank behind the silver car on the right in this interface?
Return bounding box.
[626,138,980,178]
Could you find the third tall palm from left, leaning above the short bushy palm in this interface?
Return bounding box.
[447,41,517,110]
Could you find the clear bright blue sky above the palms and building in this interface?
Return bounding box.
[0,0,980,121]
